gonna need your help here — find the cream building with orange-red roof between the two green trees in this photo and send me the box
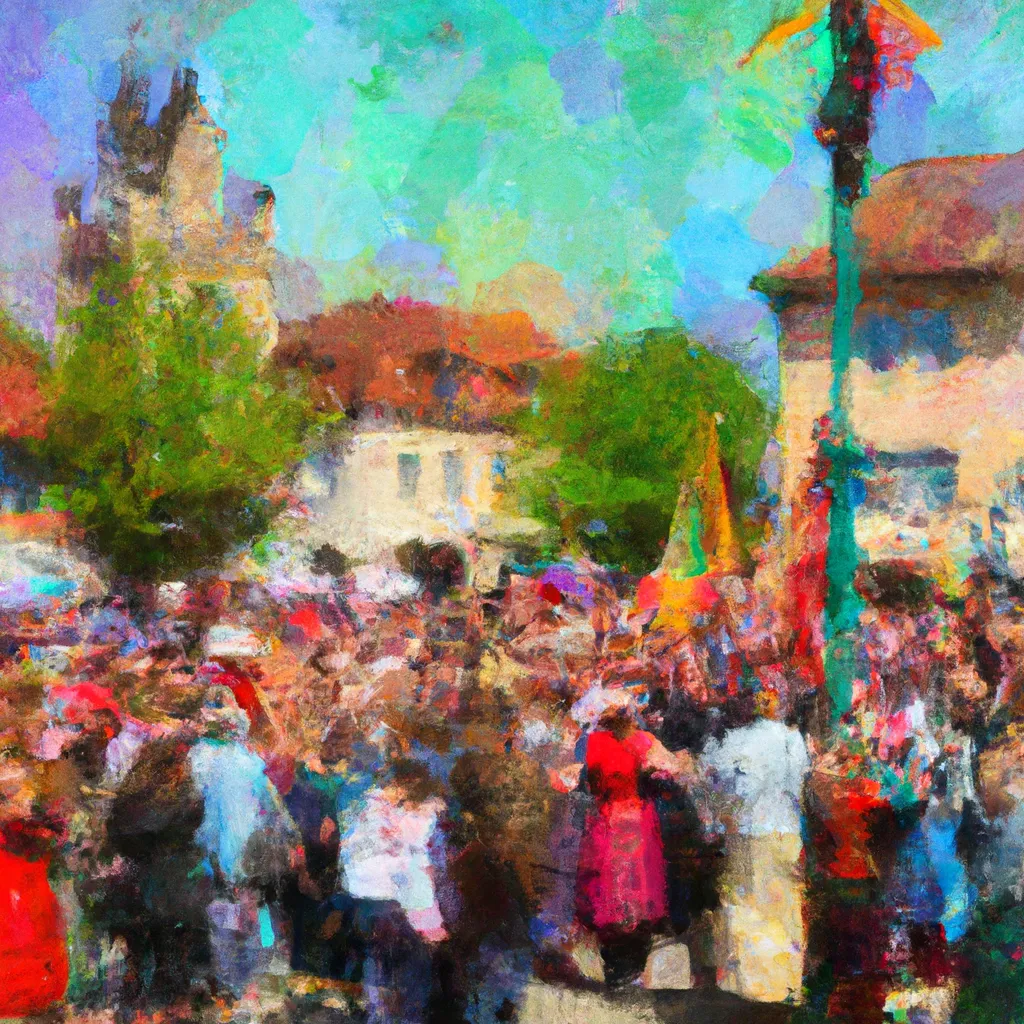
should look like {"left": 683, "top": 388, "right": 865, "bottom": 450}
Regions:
{"left": 274, "top": 295, "right": 557, "bottom": 558}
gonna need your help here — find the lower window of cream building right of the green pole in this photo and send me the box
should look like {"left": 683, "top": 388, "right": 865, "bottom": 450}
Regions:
{"left": 864, "top": 447, "right": 959, "bottom": 516}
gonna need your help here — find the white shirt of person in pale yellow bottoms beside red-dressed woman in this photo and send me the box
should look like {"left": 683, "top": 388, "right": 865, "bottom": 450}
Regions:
{"left": 701, "top": 720, "right": 810, "bottom": 836}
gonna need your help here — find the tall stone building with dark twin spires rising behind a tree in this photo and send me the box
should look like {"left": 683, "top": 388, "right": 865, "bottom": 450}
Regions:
{"left": 54, "top": 59, "right": 278, "bottom": 358}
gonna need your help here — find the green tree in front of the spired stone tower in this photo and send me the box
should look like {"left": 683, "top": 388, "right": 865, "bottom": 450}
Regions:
{"left": 40, "top": 251, "right": 313, "bottom": 580}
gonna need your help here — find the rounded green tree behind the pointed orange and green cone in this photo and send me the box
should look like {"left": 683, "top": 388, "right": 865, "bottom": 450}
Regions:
{"left": 517, "top": 329, "right": 772, "bottom": 572}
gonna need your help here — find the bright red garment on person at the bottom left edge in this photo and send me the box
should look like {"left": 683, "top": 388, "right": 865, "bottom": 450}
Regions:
{"left": 0, "top": 821, "right": 68, "bottom": 1018}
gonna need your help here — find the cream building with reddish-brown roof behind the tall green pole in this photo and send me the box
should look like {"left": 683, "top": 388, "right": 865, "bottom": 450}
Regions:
{"left": 754, "top": 153, "right": 1024, "bottom": 568}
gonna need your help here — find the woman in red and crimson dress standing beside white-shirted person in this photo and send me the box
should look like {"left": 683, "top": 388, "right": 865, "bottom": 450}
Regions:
{"left": 577, "top": 690, "right": 693, "bottom": 985}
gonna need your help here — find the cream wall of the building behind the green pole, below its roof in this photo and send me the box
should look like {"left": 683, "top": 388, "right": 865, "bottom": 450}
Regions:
{"left": 773, "top": 275, "right": 1024, "bottom": 570}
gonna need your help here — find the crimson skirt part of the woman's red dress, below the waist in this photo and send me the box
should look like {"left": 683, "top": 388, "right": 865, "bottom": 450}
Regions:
{"left": 577, "top": 800, "right": 669, "bottom": 932}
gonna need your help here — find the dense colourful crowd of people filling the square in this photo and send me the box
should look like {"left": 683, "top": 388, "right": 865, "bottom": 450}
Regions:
{"left": 0, "top": 536, "right": 1024, "bottom": 1022}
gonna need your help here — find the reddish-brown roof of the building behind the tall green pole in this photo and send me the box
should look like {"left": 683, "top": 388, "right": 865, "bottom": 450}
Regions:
{"left": 753, "top": 152, "right": 1024, "bottom": 297}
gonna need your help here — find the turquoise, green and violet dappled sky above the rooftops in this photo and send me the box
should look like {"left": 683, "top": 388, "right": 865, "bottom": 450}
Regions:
{"left": 0, "top": 0, "right": 1024, "bottom": 394}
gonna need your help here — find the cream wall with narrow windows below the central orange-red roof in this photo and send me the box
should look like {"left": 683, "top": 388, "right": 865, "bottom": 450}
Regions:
{"left": 299, "top": 429, "right": 538, "bottom": 558}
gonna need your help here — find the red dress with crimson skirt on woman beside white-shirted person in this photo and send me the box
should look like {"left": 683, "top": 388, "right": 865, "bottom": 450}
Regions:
{"left": 577, "top": 730, "right": 669, "bottom": 932}
